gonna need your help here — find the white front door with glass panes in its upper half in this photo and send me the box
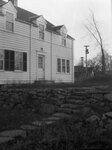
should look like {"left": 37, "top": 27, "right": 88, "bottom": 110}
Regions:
{"left": 37, "top": 55, "right": 45, "bottom": 80}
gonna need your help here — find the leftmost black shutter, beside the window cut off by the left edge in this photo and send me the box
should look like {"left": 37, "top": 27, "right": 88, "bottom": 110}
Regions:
{"left": 4, "top": 50, "right": 10, "bottom": 71}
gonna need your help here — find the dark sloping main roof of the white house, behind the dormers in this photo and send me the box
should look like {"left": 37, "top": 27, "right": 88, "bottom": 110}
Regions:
{"left": 0, "top": 0, "right": 73, "bottom": 39}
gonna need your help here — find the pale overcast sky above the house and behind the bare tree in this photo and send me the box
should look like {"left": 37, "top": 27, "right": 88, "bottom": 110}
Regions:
{"left": 18, "top": 0, "right": 112, "bottom": 62}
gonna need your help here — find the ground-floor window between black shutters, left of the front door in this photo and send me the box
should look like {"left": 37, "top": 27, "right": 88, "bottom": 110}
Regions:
{"left": 15, "top": 52, "right": 23, "bottom": 70}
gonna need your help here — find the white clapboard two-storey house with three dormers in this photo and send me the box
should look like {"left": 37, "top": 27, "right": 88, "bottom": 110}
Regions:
{"left": 0, "top": 0, "right": 74, "bottom": 84}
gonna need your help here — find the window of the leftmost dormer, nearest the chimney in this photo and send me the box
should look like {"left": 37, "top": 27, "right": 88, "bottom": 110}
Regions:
{"left": 6, "top": 12, "right": 14, "bottom": 32}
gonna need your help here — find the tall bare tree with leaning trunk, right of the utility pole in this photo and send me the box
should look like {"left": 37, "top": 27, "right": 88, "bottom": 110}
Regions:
{"left": 84, "top": 11, "right": 105, "bottom": 73}
